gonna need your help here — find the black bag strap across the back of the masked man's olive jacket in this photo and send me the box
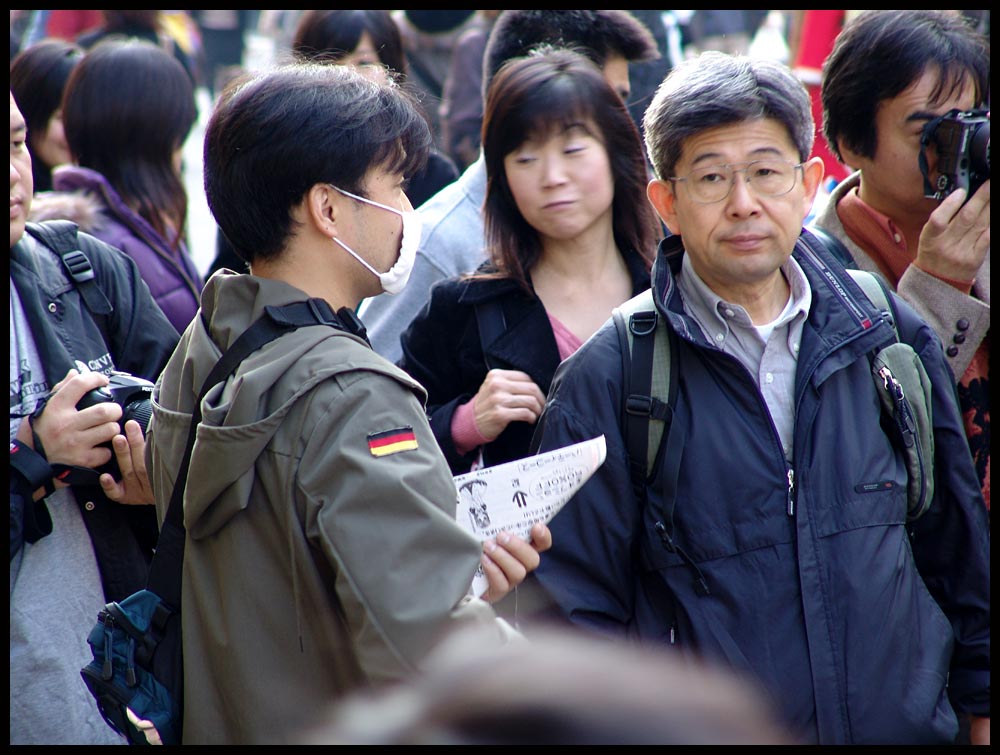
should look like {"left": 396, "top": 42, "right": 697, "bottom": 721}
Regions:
{"left": 147, "top": 299, "right": 354, "bottom": 607}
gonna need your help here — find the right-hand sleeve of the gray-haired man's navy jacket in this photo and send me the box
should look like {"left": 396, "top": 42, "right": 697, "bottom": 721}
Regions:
{"left": 895, "top": 290, "right": 990, "bottom": 716}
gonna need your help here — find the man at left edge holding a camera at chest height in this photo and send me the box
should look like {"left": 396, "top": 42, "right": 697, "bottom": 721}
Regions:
{"left": 9, "top": 95, "right": 178, "bottom": 744}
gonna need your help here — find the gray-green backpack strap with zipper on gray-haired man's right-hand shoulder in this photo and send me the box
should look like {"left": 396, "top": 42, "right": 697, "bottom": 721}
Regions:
{"left": 847, "top": 270, "right": 934, "bottom": 521}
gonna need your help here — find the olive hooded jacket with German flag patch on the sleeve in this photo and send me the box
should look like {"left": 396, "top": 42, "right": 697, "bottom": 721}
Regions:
{"left": 147, "top": 271, "right": 510, "bottom": 744}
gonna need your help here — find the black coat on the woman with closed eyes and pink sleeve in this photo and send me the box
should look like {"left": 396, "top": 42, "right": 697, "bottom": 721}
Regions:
{"left": 399, "top": 253, "right": 649, "bottom": 475}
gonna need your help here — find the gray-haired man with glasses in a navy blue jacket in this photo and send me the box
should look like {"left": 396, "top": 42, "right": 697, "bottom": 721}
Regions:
{"left": 522, "top": 52, "right": 990, "bottom": 744}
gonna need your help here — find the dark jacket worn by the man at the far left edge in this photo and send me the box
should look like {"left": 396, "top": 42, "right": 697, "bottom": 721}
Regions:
{"left": 10, "top": 224, "right": 178, "bottom": 600}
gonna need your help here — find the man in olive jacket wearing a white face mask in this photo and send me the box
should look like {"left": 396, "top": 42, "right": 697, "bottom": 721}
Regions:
{"left": 147, "top": 66, "right": 551, "bottom": 744}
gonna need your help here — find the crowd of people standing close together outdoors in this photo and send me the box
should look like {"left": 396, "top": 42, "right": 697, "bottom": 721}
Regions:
{"left": 10, "top": 10, "right": 990, "bottom": 745}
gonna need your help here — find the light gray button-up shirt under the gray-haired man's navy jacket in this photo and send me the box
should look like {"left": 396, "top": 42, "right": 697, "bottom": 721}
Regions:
{"left": 677, "top": 255, "right": 812, "bottom": 461}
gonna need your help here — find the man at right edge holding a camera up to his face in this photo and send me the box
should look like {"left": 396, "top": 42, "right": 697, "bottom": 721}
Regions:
{"left": 815, "top": 10, "right": 990, "bottom": 511}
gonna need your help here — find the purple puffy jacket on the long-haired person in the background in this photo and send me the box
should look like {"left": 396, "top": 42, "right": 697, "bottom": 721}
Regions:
{"left": 52, "top": 165, "right": 205, "bottom": 333}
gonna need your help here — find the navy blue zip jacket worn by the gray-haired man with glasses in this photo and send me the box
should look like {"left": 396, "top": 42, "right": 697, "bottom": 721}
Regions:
{"left": 533, "top": 232, "right": 990, "bottom": 744}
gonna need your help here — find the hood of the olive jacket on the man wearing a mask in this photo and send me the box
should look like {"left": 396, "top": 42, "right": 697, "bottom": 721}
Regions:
{"left": 153, "top": 271, "right": 415, "bottom": 538}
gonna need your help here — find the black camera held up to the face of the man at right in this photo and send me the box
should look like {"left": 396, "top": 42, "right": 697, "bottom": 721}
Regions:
{"left": 920, "top": 110, "right": 990, "bottom": 199}
